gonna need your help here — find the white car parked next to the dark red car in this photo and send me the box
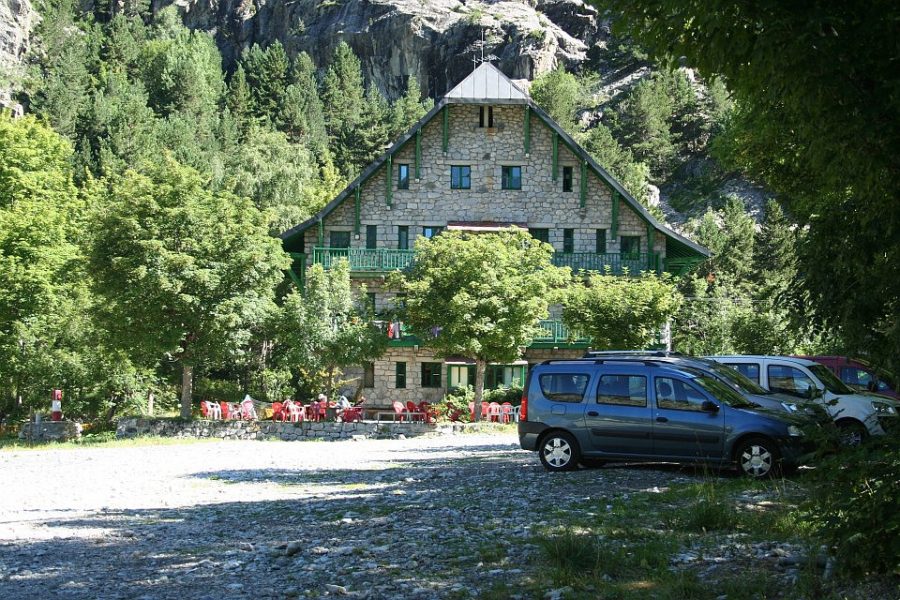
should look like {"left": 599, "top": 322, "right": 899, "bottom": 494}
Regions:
{"left": 707, "top": 356, "right": 900, "bottom": 444}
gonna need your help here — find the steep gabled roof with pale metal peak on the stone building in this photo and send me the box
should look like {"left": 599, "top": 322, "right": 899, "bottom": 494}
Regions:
{"left": 279, "top": 63, "right": 710, "bottom": 258}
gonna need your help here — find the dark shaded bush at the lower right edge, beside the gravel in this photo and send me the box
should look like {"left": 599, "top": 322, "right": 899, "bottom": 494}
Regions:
{"left": 804, "top": 436, "right": 900, "bottom": 575}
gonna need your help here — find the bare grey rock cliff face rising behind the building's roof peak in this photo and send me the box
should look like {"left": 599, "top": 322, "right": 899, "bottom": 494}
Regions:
{"left": 151, "top": 0, "right": 600, "bottom": 97}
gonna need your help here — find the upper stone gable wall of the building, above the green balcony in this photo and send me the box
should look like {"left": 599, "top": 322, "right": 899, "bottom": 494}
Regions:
{"left": 304, "top": 104, "right": 665, "bottom": 260}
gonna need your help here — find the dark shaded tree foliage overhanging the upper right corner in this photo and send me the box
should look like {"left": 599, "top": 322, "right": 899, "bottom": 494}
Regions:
{"left": 604, "top": 0, "right": 900, "bottom": 376}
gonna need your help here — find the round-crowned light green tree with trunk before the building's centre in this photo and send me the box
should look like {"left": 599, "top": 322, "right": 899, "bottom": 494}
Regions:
{"left": 399, "top": 228, "right": 567, "bottom": 415}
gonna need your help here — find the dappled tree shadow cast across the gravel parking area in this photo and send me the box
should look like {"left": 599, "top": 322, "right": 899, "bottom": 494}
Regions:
{"left": 0, "top": 444, "right": 716, "bottom": 600}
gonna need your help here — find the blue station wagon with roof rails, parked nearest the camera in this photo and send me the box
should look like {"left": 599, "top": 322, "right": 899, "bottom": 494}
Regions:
{"left": 519, "top": 358, "right": 808, "bottom": 478}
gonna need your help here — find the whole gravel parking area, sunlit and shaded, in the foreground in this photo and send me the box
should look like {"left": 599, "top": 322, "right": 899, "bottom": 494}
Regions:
{"left": 0, "top": 434, "right": 708, "bottom": 600}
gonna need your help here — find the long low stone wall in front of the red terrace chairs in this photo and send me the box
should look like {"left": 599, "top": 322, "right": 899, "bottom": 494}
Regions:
{"left": 116, "top": 418, "right": 453, "bottom": 441}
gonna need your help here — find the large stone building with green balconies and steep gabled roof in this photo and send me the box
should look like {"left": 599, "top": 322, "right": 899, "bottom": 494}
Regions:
{"left": 281, "top": 63, "right": 708, "bottom": 405}
